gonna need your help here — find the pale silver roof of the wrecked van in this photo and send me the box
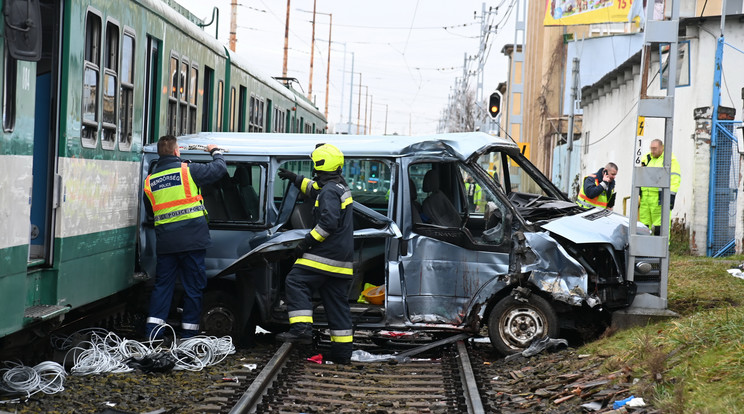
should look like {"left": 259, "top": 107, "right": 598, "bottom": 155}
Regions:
{"left": 144, "top": 132, "right": 517, "bottom": 160}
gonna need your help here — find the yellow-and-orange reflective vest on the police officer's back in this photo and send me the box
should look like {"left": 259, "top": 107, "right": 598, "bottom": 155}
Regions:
{"left": 145, "top": 163, "right": 207, "bottom": 226}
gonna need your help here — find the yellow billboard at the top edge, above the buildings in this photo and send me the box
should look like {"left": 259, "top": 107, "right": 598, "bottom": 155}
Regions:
{"left": 543, "top": 0, "right": 643, "bottom": 26}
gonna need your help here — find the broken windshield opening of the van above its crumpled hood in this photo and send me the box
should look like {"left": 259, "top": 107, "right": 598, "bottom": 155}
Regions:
{"left": 478, "top": 148, "right": 579, "bottom": 221}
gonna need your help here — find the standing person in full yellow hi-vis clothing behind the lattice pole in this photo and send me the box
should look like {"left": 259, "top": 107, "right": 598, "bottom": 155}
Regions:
{"left": 638, "top": 139, "right": 682, "bottom": 236}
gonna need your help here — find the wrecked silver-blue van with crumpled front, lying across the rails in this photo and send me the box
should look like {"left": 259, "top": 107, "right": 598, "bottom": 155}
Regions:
{"left": 140, "top": 133, "right": 636, "bottom": 354}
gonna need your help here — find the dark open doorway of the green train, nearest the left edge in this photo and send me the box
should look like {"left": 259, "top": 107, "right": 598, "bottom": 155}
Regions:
{"left": 27, "top": 0, "right": 62, "bottom": 266}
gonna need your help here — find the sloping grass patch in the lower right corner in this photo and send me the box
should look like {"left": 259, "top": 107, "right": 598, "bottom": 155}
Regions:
{"left": 580, "top": 256, "right": 744, "bottom": 413}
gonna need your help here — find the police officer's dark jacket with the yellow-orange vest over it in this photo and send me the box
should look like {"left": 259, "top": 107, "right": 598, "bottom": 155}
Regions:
{"left": 144, "top": 151, "right": 227, "bottom": 254}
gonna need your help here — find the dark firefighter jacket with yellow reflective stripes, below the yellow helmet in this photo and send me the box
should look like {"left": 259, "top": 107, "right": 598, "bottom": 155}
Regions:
{"left": 295, "top": 173, "right": 354, "bottom": 278}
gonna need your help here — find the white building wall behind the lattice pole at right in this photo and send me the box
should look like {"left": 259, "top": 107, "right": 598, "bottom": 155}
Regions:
{"left": 578, "top": 19, "right": 744, "bottom": 254}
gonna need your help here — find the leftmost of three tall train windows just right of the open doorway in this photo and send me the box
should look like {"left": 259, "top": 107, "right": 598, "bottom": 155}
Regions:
{"left": 80, "top": 11, "right": 101, "bottom": 148}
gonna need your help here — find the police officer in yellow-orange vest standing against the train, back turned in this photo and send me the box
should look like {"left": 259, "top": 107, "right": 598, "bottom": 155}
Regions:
{"left": 145, "top": 135, "right": 227, "bottom": 338}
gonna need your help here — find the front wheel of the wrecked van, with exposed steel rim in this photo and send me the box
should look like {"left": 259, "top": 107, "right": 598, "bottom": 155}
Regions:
{"left": 488, "top": 295, "right": 560, "bottom": 355}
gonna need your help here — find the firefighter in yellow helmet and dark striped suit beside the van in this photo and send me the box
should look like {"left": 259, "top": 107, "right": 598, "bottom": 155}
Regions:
{"left": 277, "top": 144, "right": 354, "bottom": 364}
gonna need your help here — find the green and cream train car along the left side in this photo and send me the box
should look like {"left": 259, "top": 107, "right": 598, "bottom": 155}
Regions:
{"left": 0, "top": 0, "right": 326, "bottom": 350}
